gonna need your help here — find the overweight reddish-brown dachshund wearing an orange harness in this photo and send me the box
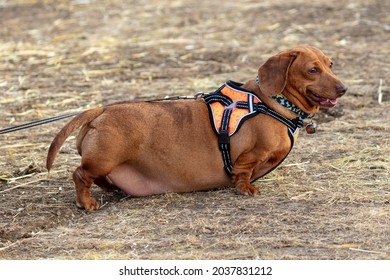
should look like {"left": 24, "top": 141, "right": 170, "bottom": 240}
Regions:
{"left": 46, "top": 46, "right": 347, "bottom": 211}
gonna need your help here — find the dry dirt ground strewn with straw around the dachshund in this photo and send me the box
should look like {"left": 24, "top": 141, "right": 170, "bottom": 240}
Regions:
{"left": 0, "top": 0, "right": 390, "bottom": 259}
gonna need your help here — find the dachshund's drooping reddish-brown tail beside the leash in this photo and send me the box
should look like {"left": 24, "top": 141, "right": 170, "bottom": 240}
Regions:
{"left": 46, "top": 107, "right": 104, "bottom": 171}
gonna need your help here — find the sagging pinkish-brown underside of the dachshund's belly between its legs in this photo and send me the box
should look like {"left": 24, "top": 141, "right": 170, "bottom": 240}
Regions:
{"left": 107, "top": 164, "right": 231, "bottom": 196}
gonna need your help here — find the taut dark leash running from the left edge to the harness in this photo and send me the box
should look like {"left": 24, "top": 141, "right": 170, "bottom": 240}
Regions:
{"left": 0, "top": 92, "right": 205, "bottom": 135}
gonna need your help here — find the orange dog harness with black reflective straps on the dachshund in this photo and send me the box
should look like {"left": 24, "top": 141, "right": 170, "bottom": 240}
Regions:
{"left": 203, "top": 81, "right": 303, "bottom": 175}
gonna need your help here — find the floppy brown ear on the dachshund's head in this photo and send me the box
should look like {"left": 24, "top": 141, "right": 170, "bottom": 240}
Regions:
{"left": 259, "top": 52, "right": 298, "bottom": 96}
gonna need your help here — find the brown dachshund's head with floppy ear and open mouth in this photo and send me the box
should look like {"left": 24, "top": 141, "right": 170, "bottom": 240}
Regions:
{"left": 259, "top": 46, "right": 347, "bottom": 114}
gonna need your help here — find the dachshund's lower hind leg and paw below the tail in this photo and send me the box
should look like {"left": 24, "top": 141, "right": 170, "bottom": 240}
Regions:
{"left": 73, "top": 166, "right": 100, "bottom": 212}
